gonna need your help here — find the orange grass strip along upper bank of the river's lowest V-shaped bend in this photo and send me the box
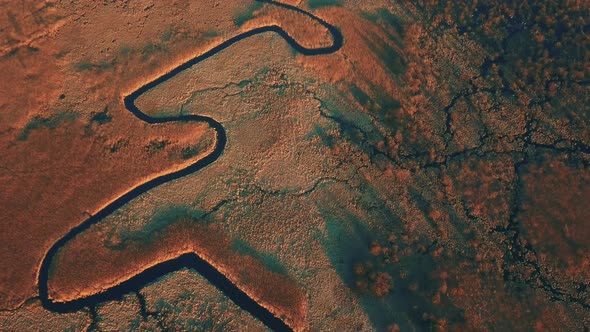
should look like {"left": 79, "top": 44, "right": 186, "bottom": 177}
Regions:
{"left": 49, "top": 220, "right": 306, "bottom": 331}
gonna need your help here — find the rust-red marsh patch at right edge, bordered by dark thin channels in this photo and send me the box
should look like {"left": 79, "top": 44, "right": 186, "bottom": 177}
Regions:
{"left": 518, "top": 155, "right": 590, "bottom": 281}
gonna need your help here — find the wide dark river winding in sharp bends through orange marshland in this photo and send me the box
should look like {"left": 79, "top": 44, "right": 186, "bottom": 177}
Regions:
{"left": 38, "top": 0, "right": 343, "bottom": 331}
